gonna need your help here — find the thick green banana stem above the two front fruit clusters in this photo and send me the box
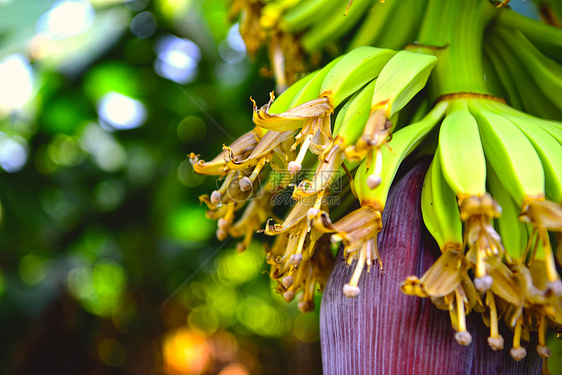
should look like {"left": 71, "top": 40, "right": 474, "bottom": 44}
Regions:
{"left": 410, "top": 0, "right": 498, "bottom": 100}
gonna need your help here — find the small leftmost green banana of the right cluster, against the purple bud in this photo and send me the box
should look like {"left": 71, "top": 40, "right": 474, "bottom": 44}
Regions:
{"left": 421, "top": 154, "right": 464, "bottom": 252}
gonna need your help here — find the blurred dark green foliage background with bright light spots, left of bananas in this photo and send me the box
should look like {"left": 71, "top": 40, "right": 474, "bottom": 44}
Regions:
{"left": 0, "top": 0, "right": 321, "bottom": 375}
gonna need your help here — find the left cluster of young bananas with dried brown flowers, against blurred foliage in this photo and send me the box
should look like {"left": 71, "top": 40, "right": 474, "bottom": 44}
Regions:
{"left": 190, "top": 46, "right": 438, "bottom": 311}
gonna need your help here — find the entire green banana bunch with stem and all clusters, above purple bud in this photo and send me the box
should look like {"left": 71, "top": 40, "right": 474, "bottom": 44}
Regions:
{"left": 194, "top": 0, "right": 562, "bottom": 368}
